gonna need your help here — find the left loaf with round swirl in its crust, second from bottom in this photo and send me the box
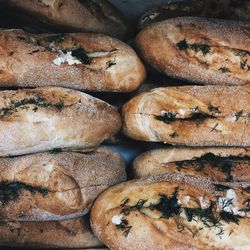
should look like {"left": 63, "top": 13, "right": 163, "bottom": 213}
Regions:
{"left": 0, "top": 148, "right": 126, "bottom": 221}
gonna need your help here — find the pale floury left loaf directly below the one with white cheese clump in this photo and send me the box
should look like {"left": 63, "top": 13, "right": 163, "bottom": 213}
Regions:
{"left": 0, "top": 87, "right": 121, "bottom": 156}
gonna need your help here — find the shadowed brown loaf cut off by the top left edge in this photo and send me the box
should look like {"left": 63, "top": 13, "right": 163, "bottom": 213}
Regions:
{"left": 1, "top": 0, "right": 128, "bottom": 38}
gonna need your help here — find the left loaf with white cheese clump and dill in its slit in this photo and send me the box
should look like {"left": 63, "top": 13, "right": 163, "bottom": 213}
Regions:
{"left": 0, "top": 29, "right": 146, "bottom": 92}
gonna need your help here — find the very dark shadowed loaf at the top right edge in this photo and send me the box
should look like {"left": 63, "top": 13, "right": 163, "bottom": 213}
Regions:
{"left": 138, "top": 0, "right": 250, "bottom": 29}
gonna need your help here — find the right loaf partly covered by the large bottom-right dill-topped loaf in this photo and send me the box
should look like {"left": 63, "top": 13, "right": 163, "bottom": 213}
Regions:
{"left": 133, "top": 147, "right": 250, "bottom": 182}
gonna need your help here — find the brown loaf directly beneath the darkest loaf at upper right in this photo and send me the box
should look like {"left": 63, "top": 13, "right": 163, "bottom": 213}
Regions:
{"left": 136, "top": 17, "right": 250, "bottom": 85}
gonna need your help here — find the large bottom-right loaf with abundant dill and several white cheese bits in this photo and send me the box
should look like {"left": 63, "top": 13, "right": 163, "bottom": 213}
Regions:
{"left": 91, "top": 174, "right": 250, "bottom": 250}
